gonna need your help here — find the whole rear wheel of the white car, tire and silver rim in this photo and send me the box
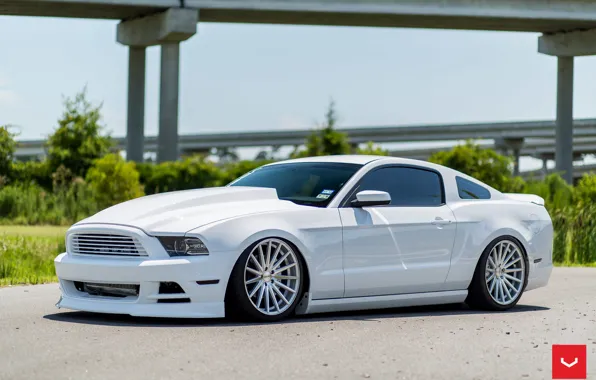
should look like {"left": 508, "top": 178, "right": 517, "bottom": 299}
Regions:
{"left": 466, "top": 236, "right": 528, "bottom": 310}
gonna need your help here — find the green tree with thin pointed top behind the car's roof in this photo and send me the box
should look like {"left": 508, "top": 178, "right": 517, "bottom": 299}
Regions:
{"left": 291, "top": 100, "right": 352, "bottom": 158}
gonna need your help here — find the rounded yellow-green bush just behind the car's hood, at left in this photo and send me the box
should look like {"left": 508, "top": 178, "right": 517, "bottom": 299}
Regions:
{"left": 87, "top": 153, "right": 144, "bottom": 208}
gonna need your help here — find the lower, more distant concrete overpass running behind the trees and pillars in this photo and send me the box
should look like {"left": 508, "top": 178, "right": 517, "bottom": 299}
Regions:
{"left": 16, "top": 119, "right": 596, "bottom": 174}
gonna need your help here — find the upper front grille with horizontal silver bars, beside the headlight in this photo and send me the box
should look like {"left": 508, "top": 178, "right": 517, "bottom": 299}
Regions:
{"left": 71, "top": 234, "right": 147, "bottom": 256}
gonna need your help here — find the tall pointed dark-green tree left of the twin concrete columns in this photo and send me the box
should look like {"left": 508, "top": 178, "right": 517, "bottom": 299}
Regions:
{"left": 48, "top": 88, "right": 112, "bottom": 177}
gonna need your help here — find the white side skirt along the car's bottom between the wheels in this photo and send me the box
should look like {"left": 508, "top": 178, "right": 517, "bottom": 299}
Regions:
{"left": 296, "top": 290, "right": 468, "bottom": 314}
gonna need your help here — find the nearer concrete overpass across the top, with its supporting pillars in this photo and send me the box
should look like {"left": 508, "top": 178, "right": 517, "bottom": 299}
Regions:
{"left": 0, "top": 0, "right": 596, "bottom": 182}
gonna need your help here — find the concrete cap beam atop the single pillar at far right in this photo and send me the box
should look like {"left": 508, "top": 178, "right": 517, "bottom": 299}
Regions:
{"left": 538, "top": 29, "right": 596, "bottom": 57}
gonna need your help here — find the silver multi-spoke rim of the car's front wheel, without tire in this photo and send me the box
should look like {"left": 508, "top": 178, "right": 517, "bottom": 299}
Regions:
{"left": 244, "top": 238, "right": 300, "bottom": 315}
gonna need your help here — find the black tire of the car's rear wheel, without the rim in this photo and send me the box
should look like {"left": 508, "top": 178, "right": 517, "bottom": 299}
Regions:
{"left": 465, "top": 236, "right": 529, "bottom": 311}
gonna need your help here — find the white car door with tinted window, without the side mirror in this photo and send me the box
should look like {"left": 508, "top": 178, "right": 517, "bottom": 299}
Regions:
{"left": 339, "top": 166, "right": 456, "bottom": 297}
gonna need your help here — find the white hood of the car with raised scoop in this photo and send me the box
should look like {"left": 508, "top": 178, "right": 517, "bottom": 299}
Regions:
{"left": 75, "top": 187, "right": 305, "bottom": 235}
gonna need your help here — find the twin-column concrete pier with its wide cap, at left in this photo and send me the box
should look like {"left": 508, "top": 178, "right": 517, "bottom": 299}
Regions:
{"left": 117, "top": 8, "right": 198, "bottom": 162}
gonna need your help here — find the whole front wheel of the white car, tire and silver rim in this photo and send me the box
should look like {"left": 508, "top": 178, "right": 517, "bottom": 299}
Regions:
{"left": 226, "top": 238, "right": 304, "bottom": 322}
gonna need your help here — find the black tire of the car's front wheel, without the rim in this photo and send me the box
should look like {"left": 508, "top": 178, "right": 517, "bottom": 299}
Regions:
{"left": 225, "top": 238, "right": 305, "bottom": 322}
